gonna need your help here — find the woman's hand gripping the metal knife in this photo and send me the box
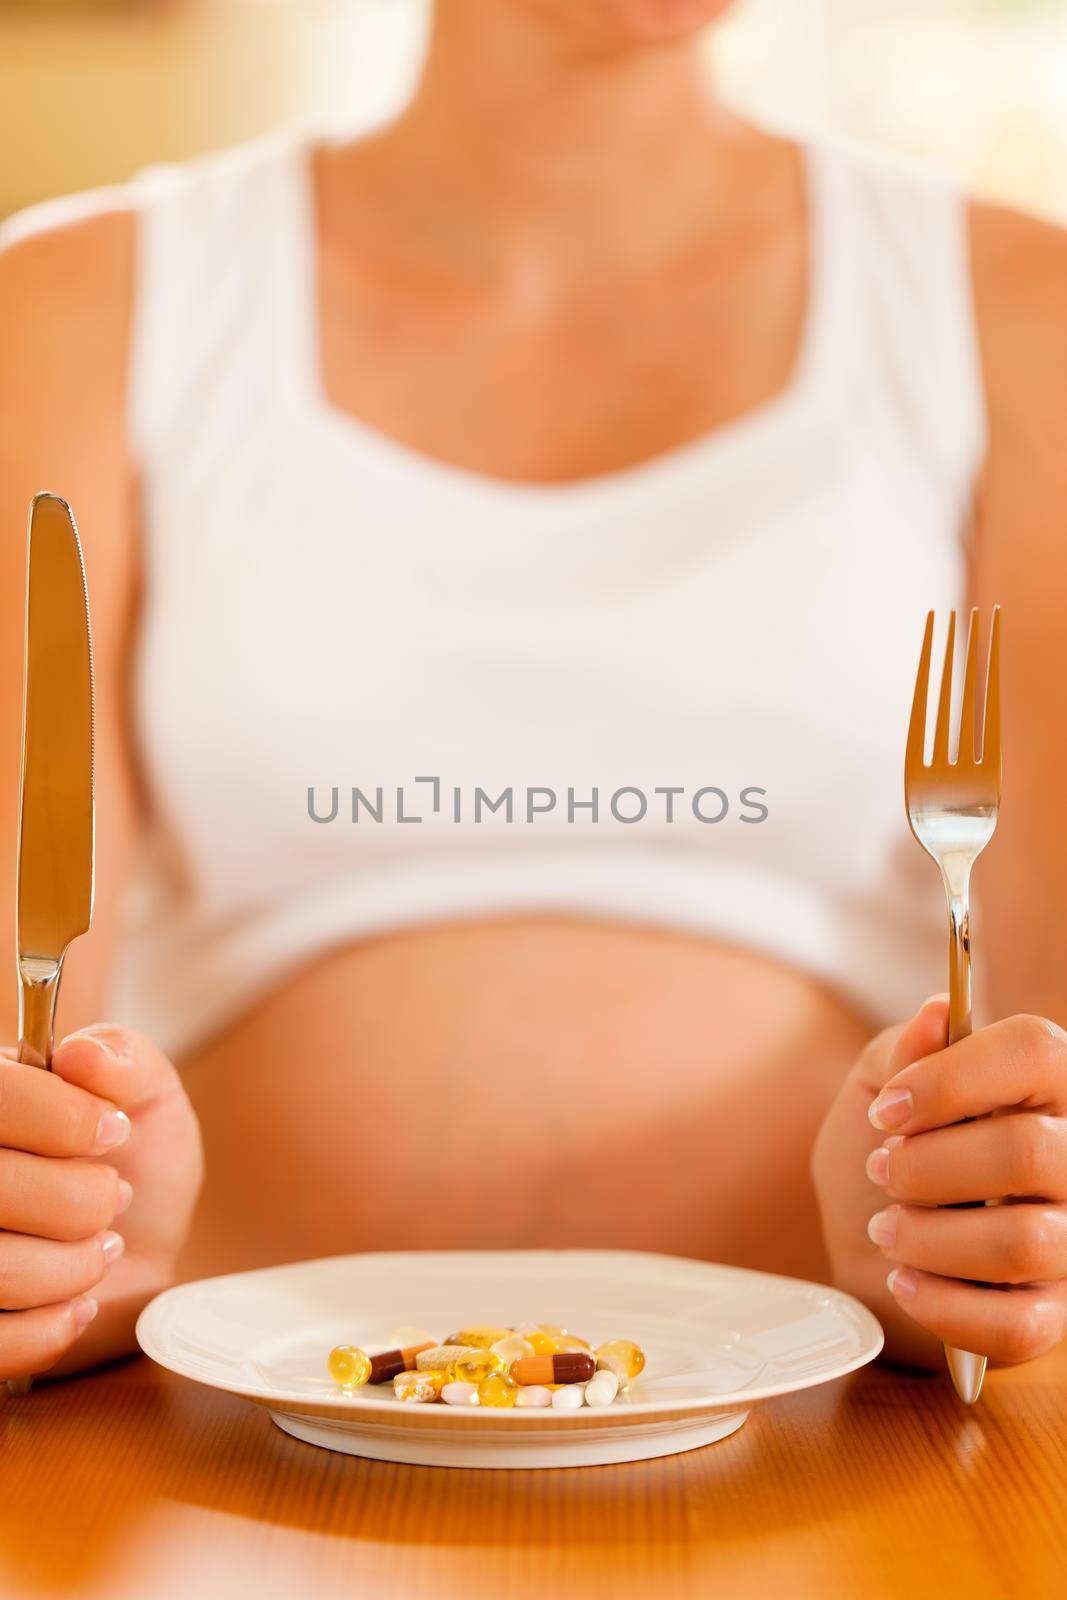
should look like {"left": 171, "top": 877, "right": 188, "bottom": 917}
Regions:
{"left": 0, "top": 1024, "right": 203, "bottom": 1378}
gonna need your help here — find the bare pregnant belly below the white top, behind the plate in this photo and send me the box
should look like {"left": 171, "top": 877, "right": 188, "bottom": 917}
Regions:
{"left": 177, "top": 918, "right": 870, "bottom": 1280}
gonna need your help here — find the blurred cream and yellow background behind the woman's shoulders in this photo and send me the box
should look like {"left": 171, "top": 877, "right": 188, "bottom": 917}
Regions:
{"left": 0, "top": 0, "right": 1067, "bottom": 219}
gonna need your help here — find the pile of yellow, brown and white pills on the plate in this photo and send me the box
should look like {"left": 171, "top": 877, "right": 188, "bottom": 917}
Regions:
{"left": 326, "top": 1323, "right": 645, "bottom": 1411}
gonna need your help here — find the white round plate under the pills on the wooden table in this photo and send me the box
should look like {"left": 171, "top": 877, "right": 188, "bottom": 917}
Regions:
{"left": 138, "top": 1250, "right": 881, "bottom": 1467}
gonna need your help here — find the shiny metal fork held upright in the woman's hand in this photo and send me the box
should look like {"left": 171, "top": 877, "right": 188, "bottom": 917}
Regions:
{"left": 904, "top": 606, "right": 1001, "bottom": 1405}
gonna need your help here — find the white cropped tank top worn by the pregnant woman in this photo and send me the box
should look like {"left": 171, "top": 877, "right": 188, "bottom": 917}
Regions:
{"left": 27, "top": 136, "right": 984, "bottom": 1054}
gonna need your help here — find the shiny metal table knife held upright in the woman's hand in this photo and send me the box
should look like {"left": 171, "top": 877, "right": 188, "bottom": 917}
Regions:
{"left": 8, "top": 494, "right": 94, "bottom": 1394}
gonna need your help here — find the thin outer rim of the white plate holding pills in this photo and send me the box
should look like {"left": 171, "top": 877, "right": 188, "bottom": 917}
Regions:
{"left": 134, "top": 1246, "right": 885, "bottom": 1430}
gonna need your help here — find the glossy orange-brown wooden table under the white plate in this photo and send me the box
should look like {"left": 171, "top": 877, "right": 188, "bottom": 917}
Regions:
{"left": 0, "top": 1352, "right": 1067, "bottom": 1600}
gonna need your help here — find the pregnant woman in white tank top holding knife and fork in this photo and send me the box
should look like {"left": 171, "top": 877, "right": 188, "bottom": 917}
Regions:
{"left": 0, "top": 0, "right": 1067, "bottom": 1376}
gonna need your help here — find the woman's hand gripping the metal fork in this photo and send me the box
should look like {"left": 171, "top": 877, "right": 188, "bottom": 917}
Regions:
{"left": 813, "top": 995, "right": 1067, "bottom": 1365}
